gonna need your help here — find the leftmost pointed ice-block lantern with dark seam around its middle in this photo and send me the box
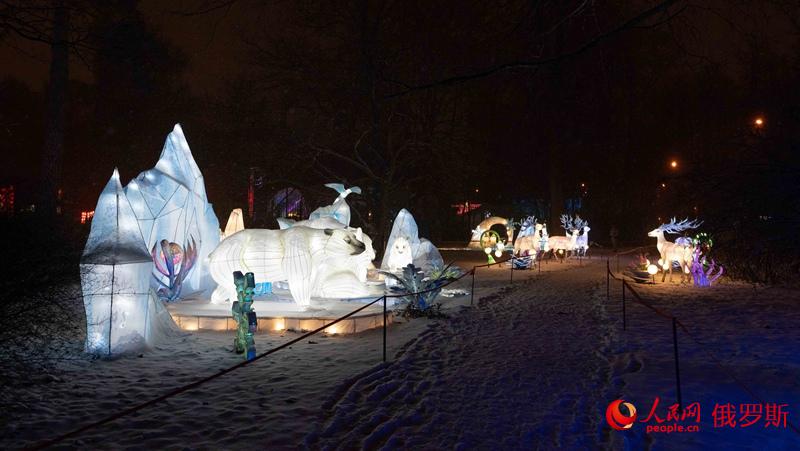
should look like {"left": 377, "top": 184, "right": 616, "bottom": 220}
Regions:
{"left": 80, "top": 169, "right": 163, "bottom": 355}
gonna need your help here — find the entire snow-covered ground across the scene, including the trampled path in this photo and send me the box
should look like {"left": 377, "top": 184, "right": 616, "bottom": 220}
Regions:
{"left": 0, "top": 252, "right": 800, "bottom": 449}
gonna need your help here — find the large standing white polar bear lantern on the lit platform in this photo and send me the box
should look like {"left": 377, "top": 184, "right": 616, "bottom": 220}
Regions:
{"left": 209, "top": 226, "right": 374, "bottom": 309}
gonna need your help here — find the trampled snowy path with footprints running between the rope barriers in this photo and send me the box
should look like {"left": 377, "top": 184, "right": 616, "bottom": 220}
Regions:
{"left": 306, "top": 262, "right": 611, "bottom": 449}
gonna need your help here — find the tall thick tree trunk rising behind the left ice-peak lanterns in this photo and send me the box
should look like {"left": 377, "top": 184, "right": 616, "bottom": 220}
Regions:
{"left": 37, "top": 0, "right": 69, "bottom": 216}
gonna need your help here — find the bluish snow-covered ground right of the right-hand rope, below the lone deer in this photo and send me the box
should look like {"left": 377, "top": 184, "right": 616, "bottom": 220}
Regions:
{"left": 607, "top": 264, "right": 800, "bottom": 450}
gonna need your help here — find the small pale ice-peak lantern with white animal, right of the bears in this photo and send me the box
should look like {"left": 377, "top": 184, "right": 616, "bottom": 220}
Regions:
{"left": 381, "top": 208, "right": 444, "bottom": 273}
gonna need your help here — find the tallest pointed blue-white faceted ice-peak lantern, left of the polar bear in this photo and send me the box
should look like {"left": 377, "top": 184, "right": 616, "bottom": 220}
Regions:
{"left": 125, "top": 124, "right": 220, "bottom": 293}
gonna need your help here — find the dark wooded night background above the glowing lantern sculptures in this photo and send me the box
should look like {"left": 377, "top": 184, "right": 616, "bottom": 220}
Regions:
{"left": 0, "top": 0, "right": 800, "bottom": 281}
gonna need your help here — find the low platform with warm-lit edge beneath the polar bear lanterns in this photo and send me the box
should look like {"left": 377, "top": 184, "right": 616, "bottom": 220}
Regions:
{"left": 167, "top": 295, "right": 394, "bottom": 334}
